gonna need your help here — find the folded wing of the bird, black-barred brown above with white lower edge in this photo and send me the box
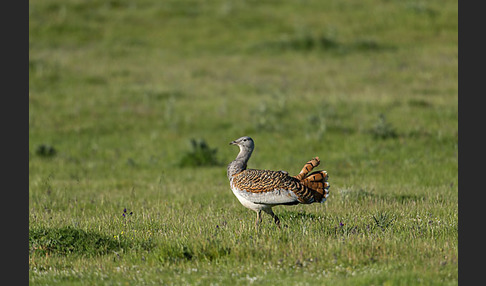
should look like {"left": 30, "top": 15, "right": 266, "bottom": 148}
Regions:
{"left": 231, "top": 169, "right": 314, "bottom": 205}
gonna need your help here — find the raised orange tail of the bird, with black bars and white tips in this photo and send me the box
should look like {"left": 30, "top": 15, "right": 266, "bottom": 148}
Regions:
{"left": 294, "top": 157, "right": 330, "bottom": 203}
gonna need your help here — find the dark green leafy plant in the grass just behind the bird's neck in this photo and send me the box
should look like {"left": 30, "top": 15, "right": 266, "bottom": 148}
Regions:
{"left": 179, "top": 139, "right": 221, "bottom": 167}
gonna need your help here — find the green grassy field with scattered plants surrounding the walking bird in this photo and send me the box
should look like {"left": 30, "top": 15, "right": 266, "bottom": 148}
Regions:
{"left": 29, "top": 0, "right": 458, "bottom": 285}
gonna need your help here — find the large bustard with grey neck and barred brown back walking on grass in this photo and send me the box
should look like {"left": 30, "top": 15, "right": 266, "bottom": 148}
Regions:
{"left": 227, "top": 136, "right": 330, "bottom": 228}
